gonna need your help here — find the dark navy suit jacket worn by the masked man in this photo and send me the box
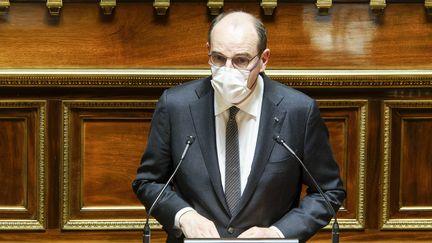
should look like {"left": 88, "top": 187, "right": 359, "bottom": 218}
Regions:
{"left": 133, "top": 74, "right": 345, "bottom": 242}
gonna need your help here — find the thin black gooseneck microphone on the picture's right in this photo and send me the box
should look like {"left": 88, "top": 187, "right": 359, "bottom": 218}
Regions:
{"left": 273, "top": 135, "right": 339, "bottom": 243}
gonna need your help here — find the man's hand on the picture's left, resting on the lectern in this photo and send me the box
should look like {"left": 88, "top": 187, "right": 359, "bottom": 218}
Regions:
{"left": 179, "top": 211, "right": 220, "bottom": 238}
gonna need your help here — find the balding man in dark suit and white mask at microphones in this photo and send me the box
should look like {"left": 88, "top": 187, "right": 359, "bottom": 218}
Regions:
{"left": 133, "top": 12, "right": 345, "bottom": 242}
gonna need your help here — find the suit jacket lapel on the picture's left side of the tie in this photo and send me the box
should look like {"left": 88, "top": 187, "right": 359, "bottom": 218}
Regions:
{"left": 189, "top": 80, "right": 229, "bottom": 214}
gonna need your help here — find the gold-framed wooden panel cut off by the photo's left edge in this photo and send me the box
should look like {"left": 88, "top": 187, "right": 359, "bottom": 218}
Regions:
{"left": 0, "top": 100, "right": 46, "bottom": 230}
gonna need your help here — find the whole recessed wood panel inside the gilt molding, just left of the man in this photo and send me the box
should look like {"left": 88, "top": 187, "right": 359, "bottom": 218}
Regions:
{"left": 63, "top": 104, "right": 153, "bottom": 220}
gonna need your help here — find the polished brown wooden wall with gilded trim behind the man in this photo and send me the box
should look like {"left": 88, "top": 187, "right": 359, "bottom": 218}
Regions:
{"left": 0, "top": 1, "right": 432, "bottom": 242}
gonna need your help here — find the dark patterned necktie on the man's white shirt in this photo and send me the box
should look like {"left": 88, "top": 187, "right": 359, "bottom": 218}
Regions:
{"left": 225, "top": 106, "right": 241, "bottom": 215}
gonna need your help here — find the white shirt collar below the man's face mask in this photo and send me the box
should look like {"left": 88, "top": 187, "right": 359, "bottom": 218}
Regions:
{"left": 214, "top": 75, "right": 264, "bottom": 118}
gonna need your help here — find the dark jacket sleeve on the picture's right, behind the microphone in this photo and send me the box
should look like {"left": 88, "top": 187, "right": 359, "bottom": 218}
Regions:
{"left": 274, "top": 102, "right": 346, "bottom": 242}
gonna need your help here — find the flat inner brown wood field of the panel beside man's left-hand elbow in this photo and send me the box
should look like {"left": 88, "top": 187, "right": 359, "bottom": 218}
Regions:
{"left": 81, "top": 117, "right": 150, "bottom": 209}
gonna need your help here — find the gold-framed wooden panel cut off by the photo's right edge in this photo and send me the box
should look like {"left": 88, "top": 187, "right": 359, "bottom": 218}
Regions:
{"left": 382, "top": 100, "right": 432, "bottom": 229}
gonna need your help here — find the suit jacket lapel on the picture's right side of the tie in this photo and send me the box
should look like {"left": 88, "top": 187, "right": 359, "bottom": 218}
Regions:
{"left": 234, "top": 75, "right": 286, "bottom": 216}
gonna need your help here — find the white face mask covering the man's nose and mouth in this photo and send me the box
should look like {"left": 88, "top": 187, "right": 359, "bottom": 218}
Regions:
{"left": 211, "top": 65, "right": 251, "bottom": 104}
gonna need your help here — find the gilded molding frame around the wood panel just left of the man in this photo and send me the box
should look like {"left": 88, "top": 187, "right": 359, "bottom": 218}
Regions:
{"left": 61, "top": 100, "right": 162, "bottom": 230}
